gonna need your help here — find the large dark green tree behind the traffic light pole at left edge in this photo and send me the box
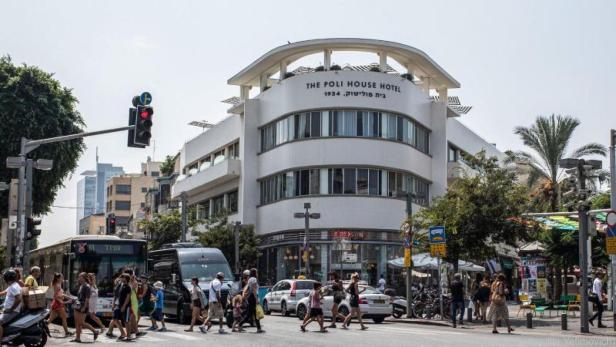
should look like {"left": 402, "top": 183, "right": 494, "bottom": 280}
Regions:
{"left": 0, "top": 57, "right": 84, "bottom": 216}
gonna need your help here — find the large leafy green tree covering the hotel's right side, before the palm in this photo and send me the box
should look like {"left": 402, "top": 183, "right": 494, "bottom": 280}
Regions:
{"left": 414, "top": 152, "right": 528, "bottom": 271}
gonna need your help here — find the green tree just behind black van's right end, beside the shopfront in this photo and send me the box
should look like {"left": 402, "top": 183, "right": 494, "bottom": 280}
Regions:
{"left": 199, "top": 213, "right": 261, "bottom": 269}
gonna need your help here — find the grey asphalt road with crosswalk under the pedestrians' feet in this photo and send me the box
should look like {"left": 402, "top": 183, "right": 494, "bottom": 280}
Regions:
{"left": 47, "top": 315, "right": 616, "bottom": 347}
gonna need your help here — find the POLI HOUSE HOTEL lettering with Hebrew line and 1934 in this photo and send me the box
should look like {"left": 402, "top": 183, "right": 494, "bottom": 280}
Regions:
{"left": 306, "top": 80, "right": 401, "bottom": 99}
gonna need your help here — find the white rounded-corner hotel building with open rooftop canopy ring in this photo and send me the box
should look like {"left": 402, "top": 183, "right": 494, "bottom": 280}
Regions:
{"left": 172, "top": 39, "right": 503, "bottom": 284}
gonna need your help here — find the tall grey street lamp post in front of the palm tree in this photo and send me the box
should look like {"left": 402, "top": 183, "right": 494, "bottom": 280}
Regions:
{"left": 558, "top": 158, "right": 602, "bottom": 333}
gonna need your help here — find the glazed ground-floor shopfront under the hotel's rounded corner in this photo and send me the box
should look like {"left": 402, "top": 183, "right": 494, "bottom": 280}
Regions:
{"left": 259, "top": 229, "right": 404, "bottom": 286}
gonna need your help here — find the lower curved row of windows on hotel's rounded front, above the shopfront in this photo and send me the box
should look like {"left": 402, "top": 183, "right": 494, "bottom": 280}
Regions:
{"left": 260, "top": 167, "right": 430, "bottom": 205}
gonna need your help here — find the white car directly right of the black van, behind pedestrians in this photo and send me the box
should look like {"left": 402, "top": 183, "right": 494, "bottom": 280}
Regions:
{"left": 263, "top": 280, "right": 316, "bottom": 316}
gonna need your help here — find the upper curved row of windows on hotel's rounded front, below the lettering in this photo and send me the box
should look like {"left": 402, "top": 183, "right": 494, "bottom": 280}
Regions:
{"left": 261, "top": 110, "right": 430, "bottom": 153}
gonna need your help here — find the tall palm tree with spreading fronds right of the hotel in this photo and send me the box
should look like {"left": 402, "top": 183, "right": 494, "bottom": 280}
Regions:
{"left": 507, "top": 114, "right": 607, "bottom": 212}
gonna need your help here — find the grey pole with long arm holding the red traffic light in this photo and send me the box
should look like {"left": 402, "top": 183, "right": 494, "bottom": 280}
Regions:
{"left": 15, "top": 125, "right": 135, "bottom": 267}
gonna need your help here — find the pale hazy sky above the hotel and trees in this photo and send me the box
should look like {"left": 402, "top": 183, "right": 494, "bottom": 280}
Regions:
{"left": 0, "top": 0, "right": 616, "bottom": 244}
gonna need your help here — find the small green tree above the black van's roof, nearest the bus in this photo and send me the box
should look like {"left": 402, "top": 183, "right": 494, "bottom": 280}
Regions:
{"left": 139, "top": 210, "right": 182, "bottom": 250}
